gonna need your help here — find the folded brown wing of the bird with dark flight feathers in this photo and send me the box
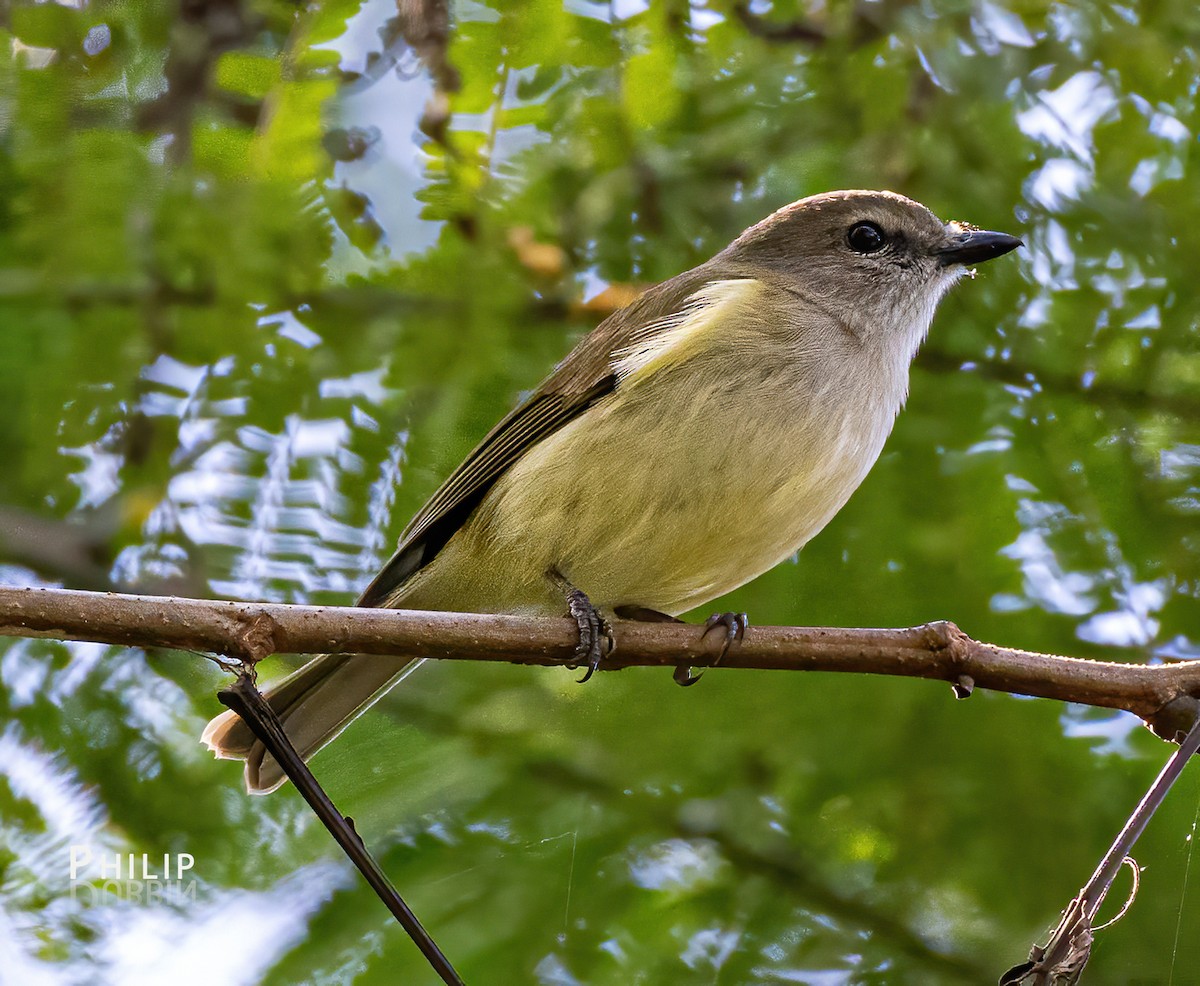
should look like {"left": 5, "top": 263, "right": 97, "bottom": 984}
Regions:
{"left": 359, "top": 264, "right": 713, "bottom": 606}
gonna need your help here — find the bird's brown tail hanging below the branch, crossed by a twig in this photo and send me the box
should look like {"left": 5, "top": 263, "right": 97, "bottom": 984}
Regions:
{"left": 200, "top": 654, "right": 421, "bottom": 794}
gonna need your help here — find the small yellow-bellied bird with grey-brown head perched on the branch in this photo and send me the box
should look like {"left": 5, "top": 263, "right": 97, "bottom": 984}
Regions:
{"left": 203, "top": 191, "right": 1021, "bottom": 793}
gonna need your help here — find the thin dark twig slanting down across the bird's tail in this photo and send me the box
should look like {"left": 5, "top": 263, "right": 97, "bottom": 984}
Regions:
{"left": 217, "top": 673, "right": 463, "bottom": 986}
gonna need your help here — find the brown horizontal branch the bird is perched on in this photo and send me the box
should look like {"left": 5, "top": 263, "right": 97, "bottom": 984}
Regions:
{"left": 7, "top": 588, "right": 1200, "bottom": 739}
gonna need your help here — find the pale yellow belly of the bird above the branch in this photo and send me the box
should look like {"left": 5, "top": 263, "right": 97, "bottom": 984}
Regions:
{"left": 396, "top": 347, "right": 902, "bottom": 614}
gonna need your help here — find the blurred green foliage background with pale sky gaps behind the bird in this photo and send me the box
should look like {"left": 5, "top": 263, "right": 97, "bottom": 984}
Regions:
{"left": 0, "top": 0, "right": 1200, "bottom": 986}
